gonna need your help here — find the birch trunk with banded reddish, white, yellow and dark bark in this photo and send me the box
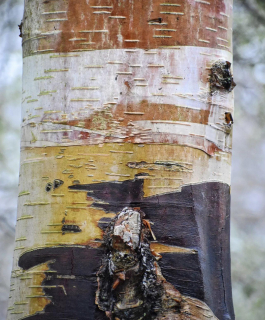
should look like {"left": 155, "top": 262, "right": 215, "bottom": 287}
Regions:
{"left": 8, "top": 0, "right": 234, "bottom": 320}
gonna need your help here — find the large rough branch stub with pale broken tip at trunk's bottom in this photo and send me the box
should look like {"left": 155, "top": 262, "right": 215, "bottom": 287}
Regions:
{"left": 95, "top": 207, "right": 217, "bottom": 320}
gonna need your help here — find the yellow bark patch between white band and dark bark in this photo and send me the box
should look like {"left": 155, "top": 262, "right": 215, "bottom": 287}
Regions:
{"left": 14, "top": 143, "right": 230, "bottom": 253}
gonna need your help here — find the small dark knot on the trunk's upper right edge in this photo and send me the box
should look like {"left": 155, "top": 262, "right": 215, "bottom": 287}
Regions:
{"left": 210, "top": 60, "right": 236, "bottom": 94}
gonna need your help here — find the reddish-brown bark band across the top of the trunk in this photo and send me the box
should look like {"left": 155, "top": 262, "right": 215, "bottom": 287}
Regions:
{"left": 23, "top": 0, "right": 232, "bottom": 57}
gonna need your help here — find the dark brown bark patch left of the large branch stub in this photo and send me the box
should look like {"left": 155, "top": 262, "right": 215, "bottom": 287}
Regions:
{"left": 19, "top": 246, "right": 107, "bottom": 320}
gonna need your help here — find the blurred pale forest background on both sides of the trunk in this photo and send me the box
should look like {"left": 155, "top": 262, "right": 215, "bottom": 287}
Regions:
{"left": 0, "top": 0, "right": 265, "bottom": 320}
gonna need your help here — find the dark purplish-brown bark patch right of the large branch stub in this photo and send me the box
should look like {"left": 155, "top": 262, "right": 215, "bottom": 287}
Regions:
{"left": 69, "top": 179, "right": 234, "bottom": 319}
